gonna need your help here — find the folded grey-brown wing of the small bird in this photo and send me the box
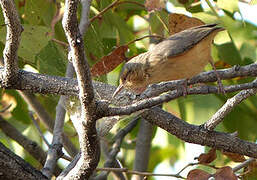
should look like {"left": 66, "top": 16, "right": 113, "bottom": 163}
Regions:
{"left": 151, "top": 24, "right": 224, "bottom": 58}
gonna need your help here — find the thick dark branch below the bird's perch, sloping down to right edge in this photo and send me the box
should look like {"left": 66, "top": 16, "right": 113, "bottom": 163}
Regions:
{"left": 142, "top": 108, "right": 257, "bottom": 158}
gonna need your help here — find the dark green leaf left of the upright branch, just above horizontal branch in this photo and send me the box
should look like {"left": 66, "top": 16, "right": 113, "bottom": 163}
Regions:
{"left": 35, "top": 41, "right": 68, "bottom": 76}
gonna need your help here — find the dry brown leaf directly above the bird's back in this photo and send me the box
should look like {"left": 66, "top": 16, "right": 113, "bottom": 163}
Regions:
{"left": 168, "top": 13, "right": 205, "bottom": 35}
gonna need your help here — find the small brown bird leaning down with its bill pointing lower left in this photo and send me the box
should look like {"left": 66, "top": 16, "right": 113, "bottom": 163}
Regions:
{"left": 113, "top": 24, "right": 224, "bottom": 97}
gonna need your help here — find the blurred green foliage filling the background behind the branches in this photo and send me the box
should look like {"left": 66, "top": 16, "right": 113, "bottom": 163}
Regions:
{"left": 0, "top": 0, "right": 257, "bottom": 179}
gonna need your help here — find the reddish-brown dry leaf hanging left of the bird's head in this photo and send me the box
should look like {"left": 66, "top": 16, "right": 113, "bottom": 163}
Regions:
{"left": 91, "top": 45, "right": 128, "bottom": 76}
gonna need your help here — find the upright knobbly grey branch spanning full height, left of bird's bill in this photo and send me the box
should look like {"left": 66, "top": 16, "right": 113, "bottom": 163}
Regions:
{"left": 62, "top": 0, "right": 100, "bottom": 179}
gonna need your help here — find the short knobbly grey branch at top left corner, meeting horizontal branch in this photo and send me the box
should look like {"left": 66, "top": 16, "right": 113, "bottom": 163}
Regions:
{"left": 0, "top": 0, "right": 23, "bottom": 83}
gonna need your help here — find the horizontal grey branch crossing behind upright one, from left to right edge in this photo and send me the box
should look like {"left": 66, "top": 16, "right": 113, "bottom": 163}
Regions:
{"left": 0, "top": 63, "right": 257, "bottom": 98}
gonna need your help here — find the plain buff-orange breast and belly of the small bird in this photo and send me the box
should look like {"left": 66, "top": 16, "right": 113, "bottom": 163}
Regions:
{"left": 148, "top": 33, "right": 214, "bottom": 84}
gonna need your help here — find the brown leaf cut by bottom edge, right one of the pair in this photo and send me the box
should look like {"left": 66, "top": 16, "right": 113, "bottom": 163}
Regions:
{"left": 214, "top": 166, "right": 237, "bottom": 180}
